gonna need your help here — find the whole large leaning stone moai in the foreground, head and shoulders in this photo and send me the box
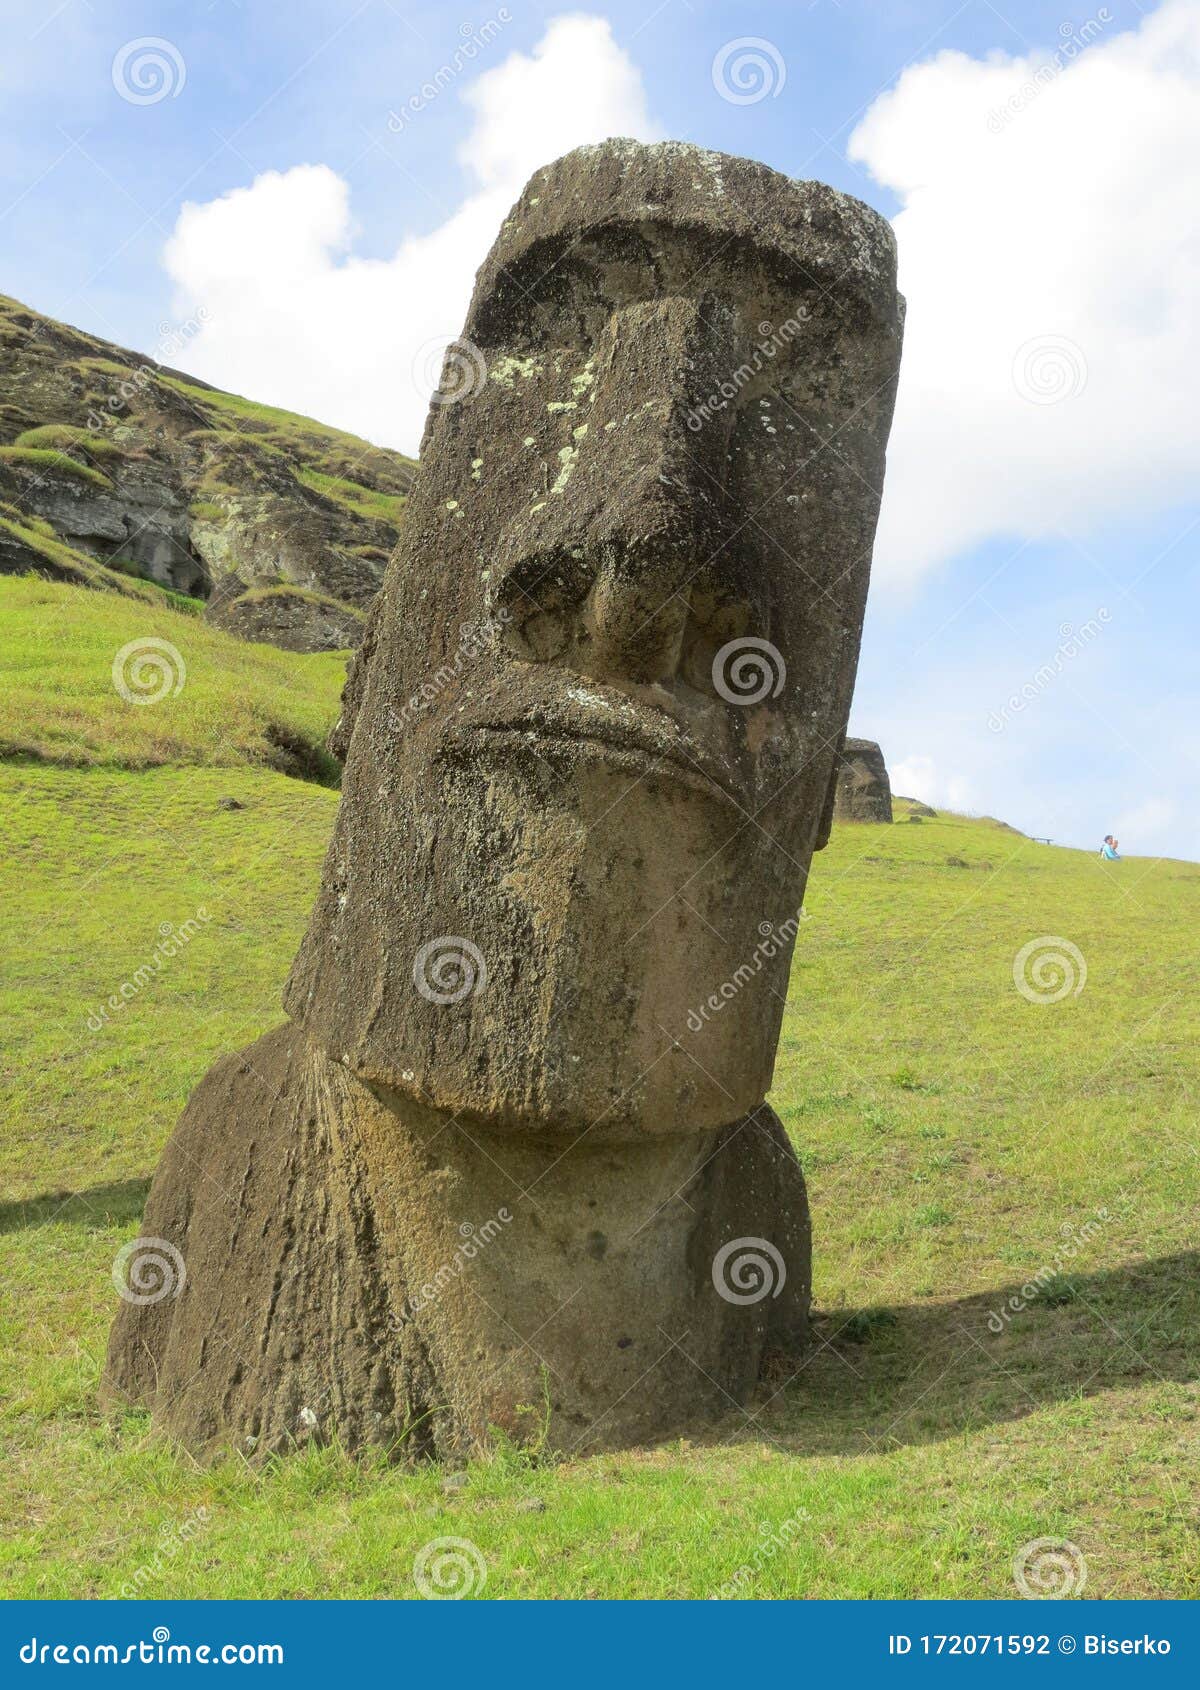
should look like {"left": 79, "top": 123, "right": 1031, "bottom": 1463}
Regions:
{"left": 106, "top": 140, "right": 903, "bottom": 1460}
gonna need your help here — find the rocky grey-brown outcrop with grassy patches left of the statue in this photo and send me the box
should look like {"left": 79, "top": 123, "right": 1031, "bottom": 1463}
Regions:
{"left": 0, "top": 296, "right": 414, "bottom": 649}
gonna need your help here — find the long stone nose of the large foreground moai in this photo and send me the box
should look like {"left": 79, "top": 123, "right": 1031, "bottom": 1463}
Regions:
{"left": 496, "top": 297, "right": 735, "bottom": 684}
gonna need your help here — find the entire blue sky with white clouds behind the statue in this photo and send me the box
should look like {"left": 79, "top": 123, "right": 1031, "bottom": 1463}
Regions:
{"left": 0, "top": 0, "right": 1200, "bottom": 859}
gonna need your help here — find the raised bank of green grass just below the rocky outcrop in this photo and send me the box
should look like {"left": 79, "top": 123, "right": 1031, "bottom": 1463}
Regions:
{"left": 0, "top": 576, "right": 345, "bottom": 781}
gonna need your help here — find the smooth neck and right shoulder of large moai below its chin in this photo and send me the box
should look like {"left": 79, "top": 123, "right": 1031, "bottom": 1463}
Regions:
{"left": 331, "top": 1058, "right": 808, "bottom": 1453}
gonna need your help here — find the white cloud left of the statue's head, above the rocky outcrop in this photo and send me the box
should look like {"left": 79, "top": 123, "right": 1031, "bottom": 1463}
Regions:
{"left": 164, "top": 15, "right": 659, "bottom": 451}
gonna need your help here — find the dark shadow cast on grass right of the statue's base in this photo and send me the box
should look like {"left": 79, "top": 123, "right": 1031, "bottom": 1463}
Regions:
{"left": 735, "top": 1251, "right": 1200, "bottom": 1455}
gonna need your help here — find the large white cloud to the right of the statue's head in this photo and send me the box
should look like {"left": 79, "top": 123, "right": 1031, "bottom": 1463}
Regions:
{"left": 848, "top": 0, "right": 1200, "bottom": 585}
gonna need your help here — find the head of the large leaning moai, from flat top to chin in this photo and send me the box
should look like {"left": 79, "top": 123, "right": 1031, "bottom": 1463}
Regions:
{"left": 286, "top": 140, "right": 903, "bottom": 1144}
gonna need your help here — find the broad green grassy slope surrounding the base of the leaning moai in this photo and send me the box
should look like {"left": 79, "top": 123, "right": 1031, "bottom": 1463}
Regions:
{"left": 0, "top": 590, "right": 1200, "bottom": 1595}
